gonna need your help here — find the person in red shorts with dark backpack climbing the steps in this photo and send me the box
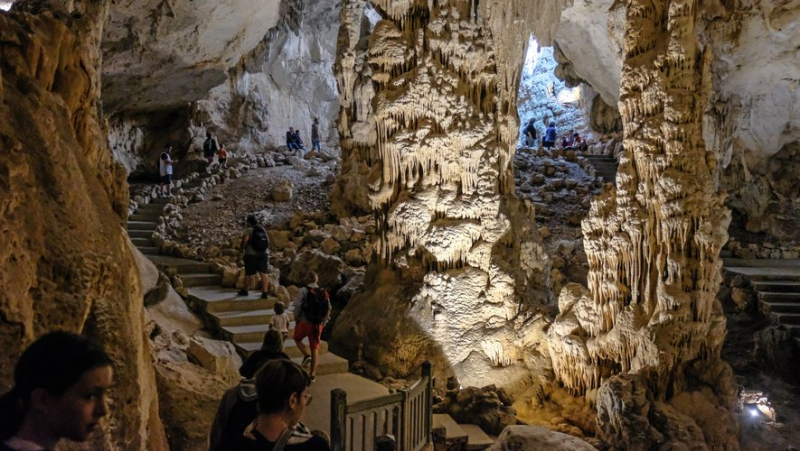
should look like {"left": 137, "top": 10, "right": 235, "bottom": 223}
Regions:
{"left": 292, "top": 271, "right": 331, "bottom": 382}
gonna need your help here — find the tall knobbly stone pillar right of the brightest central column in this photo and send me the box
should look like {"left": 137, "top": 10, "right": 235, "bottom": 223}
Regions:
{"left": 548, "top": 0, "right": 736, "bottom": 449}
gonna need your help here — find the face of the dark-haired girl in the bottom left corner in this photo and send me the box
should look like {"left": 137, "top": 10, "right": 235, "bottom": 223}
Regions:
{"left": 45, "top": 366, "right": 113, "bottom": 442}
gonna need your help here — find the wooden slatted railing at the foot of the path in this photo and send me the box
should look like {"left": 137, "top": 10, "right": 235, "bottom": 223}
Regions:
{"left": 331, "top": 362, "right": 433, "bottom": 451}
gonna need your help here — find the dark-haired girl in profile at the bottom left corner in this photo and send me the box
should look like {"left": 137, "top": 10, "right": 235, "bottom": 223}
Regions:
{"left": 0, "top": 332, "right": 113, "bottom": 451}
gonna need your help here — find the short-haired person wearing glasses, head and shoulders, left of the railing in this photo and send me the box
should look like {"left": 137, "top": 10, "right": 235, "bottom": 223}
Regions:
{"left": 216, "top": 359, "right": 331, "bottom": 451}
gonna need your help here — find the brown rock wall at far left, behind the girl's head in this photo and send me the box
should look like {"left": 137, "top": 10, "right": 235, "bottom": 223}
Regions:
{"left": 0, "top": 2, "right": 166, "bottom": 450}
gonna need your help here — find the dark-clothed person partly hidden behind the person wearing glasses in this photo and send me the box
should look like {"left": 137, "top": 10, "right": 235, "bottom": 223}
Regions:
{"left": 209, "top": 330, "right": 289, "bottom": 451}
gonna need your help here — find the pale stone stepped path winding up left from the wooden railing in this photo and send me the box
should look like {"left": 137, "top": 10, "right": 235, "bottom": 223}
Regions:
{"left": 123, "top": 189, "right": 389, "bottom": 432}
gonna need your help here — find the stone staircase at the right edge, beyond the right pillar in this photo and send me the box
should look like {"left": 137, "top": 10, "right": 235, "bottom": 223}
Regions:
{"left": 723, "top": 254, "right": 800, "bottom": 347}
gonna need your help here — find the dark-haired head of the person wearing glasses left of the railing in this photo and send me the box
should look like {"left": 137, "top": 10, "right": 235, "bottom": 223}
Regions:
{"left": 256, "top": 359, "right": 311, "bottom": 425}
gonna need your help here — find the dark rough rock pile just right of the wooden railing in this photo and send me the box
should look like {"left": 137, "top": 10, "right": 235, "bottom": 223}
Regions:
{"left": 433, "top": 382, "right": 521, "bottom": 435}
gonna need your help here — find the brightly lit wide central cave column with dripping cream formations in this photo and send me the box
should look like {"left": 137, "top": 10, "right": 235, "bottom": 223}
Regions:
{"left": 334, "top": 0, "right": 549, "bottom": 394}
